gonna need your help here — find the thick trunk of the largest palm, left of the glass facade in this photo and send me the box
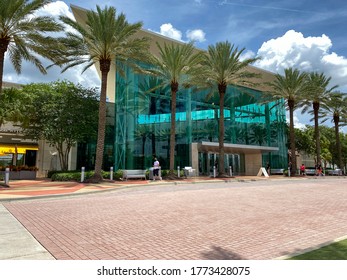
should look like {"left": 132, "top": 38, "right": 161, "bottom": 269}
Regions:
{"left": 89, "top": 60, "right": 111, "bottom": 182}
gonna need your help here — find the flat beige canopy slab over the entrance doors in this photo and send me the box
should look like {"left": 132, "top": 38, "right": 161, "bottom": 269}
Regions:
{"left": 197, "top": 142, "right": 279, "bottom": 154}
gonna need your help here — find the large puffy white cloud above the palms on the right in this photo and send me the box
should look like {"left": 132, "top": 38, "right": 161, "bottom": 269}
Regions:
{"left": 255, "top": 30, "right": 347, "bottom": 92}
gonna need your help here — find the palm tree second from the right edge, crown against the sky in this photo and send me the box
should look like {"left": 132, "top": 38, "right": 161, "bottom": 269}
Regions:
{"left": 302, "top": 72, "right": 337, "bottom": 164}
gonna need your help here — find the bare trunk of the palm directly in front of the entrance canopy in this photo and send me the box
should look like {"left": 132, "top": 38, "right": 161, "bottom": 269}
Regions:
{"left": 218, "top": 84, "right": 227, "bottom": 176}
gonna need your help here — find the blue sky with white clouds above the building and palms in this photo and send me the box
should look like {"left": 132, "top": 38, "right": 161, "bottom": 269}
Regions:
{"left": 5, "top": 0, "right": 347, "bottom": 128}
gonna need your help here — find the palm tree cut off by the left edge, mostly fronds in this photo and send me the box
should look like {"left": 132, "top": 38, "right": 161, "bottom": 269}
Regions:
{"left": 0, "top": 0, "right": 63, "bottom": 94}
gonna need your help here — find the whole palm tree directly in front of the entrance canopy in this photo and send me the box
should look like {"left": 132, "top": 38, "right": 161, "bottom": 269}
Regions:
{"left": 199, "top": 41, "right": 259, "bottom": 176}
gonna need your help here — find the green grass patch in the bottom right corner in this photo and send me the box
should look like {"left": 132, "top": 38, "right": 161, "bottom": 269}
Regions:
{"left": 289, "top": 239, "right": 347, "bottom": 260}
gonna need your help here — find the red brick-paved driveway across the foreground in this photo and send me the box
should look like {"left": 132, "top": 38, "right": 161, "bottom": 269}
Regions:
{"left": 4, "top": 178, "right": 347, "bottom": 260}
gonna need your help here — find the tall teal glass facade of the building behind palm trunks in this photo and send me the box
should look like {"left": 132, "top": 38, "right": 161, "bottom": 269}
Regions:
{"left": 78, "top": 61, "right": 287, "bottom": 171}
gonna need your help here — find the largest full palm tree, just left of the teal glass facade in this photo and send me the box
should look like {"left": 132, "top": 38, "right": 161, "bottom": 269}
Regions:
{"left": 55, "top": 6, "right": 149, "bottom": 182}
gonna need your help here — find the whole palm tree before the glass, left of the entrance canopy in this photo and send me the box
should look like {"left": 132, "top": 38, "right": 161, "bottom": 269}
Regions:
{"left": 150, "top": 43, "right": 202, "bottom": 175}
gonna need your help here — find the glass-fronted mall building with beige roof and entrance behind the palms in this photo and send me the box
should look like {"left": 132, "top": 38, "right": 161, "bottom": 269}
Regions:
{"left": 0, "top": 6, "right": 288, "bottom": 175}
